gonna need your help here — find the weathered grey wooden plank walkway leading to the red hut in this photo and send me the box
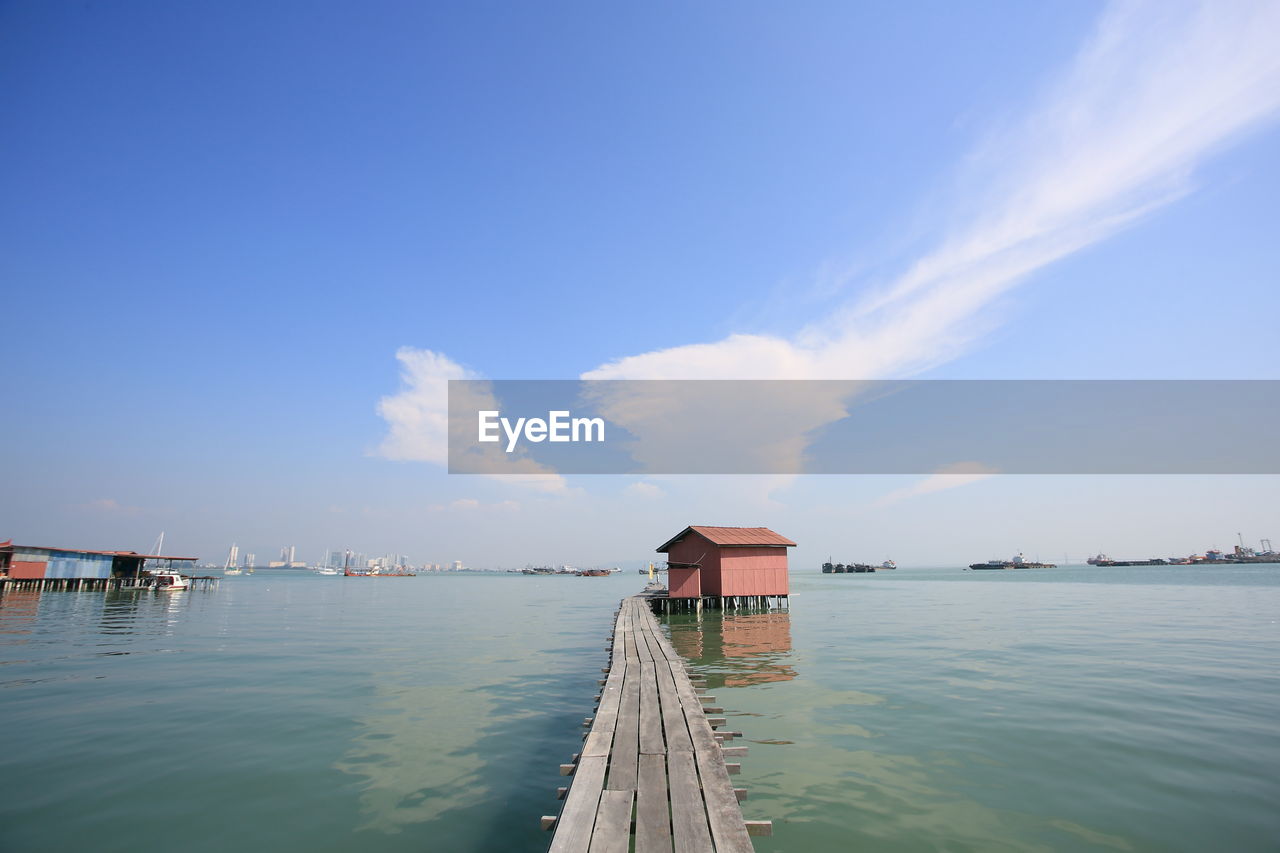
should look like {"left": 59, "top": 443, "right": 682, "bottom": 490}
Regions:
{"left": 543, "top": 596, "right": 772, "bottom": 853}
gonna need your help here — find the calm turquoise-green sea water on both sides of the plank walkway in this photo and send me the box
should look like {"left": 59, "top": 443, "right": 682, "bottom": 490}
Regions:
{"left": 0, "top": 566, "right": 1280, "bottom": 853}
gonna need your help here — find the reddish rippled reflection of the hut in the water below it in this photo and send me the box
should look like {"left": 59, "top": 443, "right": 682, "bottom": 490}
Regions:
{"left": 668, "top": 611, "right": 796, "bottom": 686}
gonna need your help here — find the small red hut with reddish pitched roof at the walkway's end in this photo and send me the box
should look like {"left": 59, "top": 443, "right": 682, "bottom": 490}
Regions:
{"left": 658, "top": 525, "right": 796, "bottom": 598}
